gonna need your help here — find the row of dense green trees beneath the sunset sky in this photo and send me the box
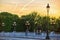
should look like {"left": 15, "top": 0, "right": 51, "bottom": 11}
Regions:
{"left": 0, "top": 12, "right": 60, "bottom": 32}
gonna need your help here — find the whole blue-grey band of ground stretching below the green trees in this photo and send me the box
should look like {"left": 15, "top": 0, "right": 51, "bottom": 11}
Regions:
{"left": 0, "top": 32, "right": 60, "bottom": 40}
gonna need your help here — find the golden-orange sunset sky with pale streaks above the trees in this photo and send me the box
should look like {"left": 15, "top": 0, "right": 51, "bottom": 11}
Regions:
{"left": 0, "top": 0, "right": 60, "bottom": 17}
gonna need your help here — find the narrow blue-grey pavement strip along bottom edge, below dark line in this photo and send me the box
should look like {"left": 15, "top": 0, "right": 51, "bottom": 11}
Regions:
{"left": 0, "top": 37, "right": 60, "bottom": 40}
